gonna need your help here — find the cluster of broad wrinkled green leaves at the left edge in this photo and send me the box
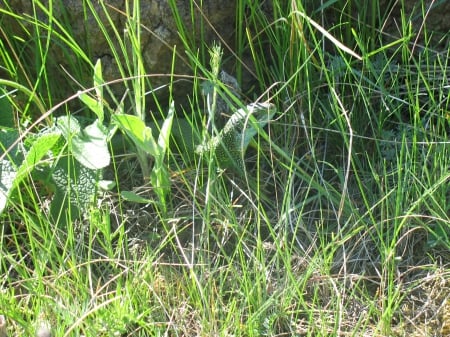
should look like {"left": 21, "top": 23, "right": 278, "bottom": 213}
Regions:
{"left": 0, "top": 61, "right": 110, "bottom": 222}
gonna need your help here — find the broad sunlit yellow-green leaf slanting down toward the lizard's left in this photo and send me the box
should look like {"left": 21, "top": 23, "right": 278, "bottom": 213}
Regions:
{"left": 113, "top": 115, "right": 160, "bottom": 157}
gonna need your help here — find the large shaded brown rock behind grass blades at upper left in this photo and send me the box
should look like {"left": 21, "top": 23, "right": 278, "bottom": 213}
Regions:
{"left": 1, "top": 0, "right": 236, "bottom": 106}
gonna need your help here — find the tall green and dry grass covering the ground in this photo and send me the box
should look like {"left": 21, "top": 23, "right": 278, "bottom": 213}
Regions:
{"left": 0, "top": 0, "right": 450, "bottom": 336}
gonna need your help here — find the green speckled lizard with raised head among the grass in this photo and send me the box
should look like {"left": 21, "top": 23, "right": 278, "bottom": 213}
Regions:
{"left": 110, "top": 71, "right": 276, "bottom": 175}
